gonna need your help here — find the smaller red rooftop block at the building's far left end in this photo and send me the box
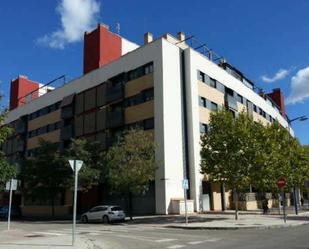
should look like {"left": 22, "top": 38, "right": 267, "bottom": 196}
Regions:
{"left": 10, "top": 76, "right": 39, "bottom": 110}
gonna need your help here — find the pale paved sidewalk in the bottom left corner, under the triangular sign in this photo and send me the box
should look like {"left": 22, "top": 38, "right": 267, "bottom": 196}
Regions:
{"left": 0, "top": 229, "right": 95, "bottom": 249}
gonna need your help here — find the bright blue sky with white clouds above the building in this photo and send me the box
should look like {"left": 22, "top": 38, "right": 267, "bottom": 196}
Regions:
{"left": 0, "top": 0, "right": 309, "bottom": 144}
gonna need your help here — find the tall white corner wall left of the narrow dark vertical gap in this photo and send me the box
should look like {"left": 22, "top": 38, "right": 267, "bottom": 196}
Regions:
{"left": 155, "top": 39, "right": 185, "bottom": 214}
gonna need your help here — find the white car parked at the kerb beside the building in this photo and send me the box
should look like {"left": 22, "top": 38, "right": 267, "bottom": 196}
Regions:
{"left": 81, "top": 206, "right": 126, "bottom": 223}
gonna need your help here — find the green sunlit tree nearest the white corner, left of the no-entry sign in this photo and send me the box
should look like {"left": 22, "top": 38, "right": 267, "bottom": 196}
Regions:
{"left": 201, "top": 110, "right": 255, "bottom": 219}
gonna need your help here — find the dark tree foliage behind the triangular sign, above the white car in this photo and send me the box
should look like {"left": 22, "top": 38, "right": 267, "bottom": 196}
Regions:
{"left": 66, "top": 139, "right": 106, "bottom": 191}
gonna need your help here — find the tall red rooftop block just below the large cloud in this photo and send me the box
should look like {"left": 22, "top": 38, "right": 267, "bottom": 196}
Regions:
{"left": 84, "top": 24, "right": 122, "bottom": 74}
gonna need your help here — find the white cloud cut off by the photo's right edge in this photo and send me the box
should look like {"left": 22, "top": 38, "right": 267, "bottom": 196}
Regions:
{"left": 286, "top": 67, "right": 309, "bottom": 104}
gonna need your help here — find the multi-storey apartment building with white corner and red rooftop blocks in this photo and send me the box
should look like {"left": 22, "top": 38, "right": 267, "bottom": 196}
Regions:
{"left": 3, "top": 24, "right": 288, "bottom": 214}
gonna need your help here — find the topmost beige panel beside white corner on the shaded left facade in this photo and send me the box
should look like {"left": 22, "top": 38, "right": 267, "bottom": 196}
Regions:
{"left": 125, "top": 73, "right": 153, "bottom": 98}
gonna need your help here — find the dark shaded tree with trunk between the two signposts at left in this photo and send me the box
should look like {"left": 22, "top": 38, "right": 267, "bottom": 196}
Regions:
{"left": 21, "top": 140, "right": 72, "bottom": 217}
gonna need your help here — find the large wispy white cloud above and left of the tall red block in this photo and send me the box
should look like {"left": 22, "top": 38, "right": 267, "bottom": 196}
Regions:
{"left": 37, "top": 0, "right": 100, "bottom": 49}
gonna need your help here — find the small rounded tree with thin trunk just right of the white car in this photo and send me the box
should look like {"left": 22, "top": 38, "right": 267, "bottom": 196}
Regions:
{"left": 106, "top": 129, "right": 157, "bottom": 219}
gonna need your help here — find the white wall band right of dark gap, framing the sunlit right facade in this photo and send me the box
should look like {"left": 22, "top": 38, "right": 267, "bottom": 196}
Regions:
{"left": 185, "top": 48, "right": 293, "bottom": 211}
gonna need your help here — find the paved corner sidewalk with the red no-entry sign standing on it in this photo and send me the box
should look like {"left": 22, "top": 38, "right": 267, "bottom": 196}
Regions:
{"left": 127, "top": 211, "right": 309, "bottom": 230}
